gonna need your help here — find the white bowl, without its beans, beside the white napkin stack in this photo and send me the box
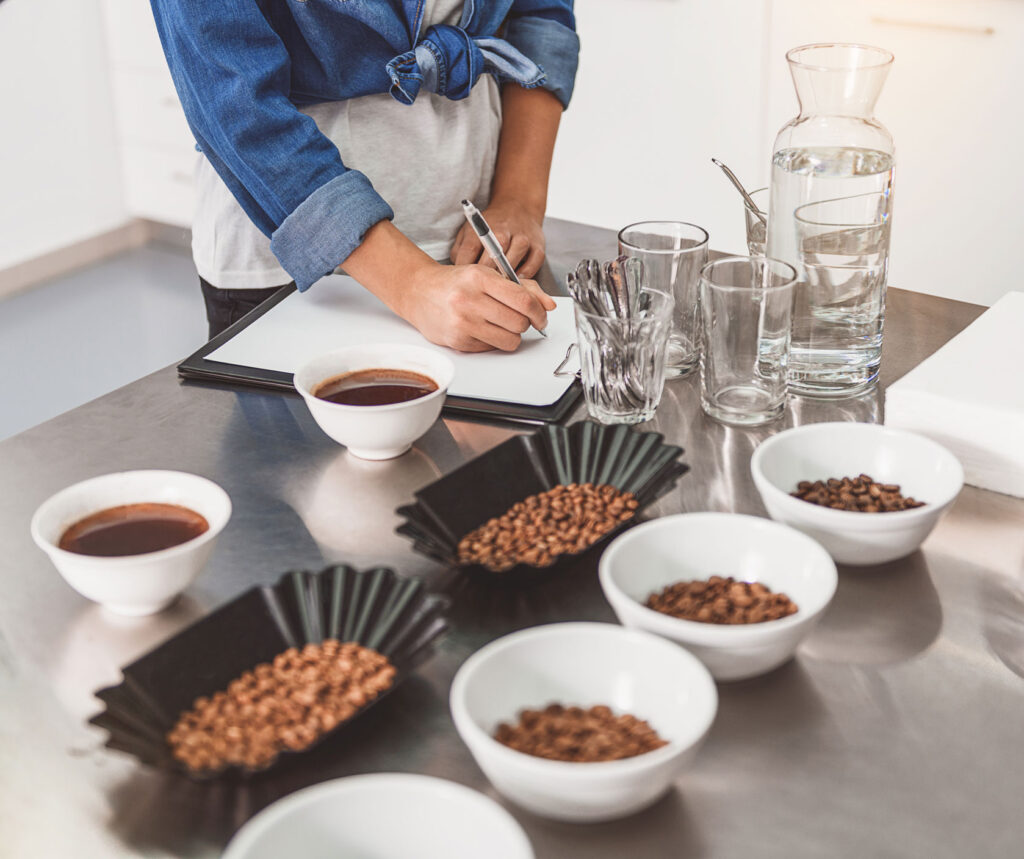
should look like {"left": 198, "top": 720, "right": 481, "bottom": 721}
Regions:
{"left": 751, "top": 423, "right": 964, "bottom": 565}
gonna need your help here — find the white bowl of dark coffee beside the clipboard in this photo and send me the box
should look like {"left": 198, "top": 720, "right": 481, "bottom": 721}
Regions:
{"left": 295, "top": 343, "right": 455, "bottom": 460}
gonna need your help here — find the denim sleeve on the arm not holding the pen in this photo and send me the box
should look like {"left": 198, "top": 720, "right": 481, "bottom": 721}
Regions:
{"left": 504, "top": 0, "right": 580, "bottom": 108}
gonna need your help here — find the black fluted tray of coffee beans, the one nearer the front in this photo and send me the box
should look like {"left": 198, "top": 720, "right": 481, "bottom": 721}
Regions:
{"left": 89, "top": 564, "right": 449, "bottom": 780}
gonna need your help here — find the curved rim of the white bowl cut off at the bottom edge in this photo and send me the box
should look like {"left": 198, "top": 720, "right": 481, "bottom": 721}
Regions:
{"left": 222, "top": 772, "right": 536, "bottom": 859}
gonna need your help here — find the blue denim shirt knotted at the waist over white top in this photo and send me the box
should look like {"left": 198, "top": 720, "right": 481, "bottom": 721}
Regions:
{"left": 152, "top": 0, "right": 580, "bottom": 290}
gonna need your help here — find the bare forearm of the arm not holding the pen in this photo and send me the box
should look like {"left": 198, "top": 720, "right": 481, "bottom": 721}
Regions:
{"left": 490, "top": 84, "right": 562, "bottom": 221}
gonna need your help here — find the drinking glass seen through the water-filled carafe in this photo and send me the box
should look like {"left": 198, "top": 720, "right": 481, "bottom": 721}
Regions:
{"left": 790, "top": 192, "right": 892, "bottom": 397}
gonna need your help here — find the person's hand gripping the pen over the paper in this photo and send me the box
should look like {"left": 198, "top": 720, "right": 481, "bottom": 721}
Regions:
{"left": 399, "top": 264, "right": 555, "bottom": 352}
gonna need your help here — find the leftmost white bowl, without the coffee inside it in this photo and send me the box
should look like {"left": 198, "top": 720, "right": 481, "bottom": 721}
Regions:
{"left": 31, "top": 471, "right": 231, "bottom": 615}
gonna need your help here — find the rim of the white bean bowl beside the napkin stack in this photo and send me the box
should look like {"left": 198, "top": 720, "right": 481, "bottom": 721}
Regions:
{"left": 751, "top": 421, "right": 964, "bottom": 530}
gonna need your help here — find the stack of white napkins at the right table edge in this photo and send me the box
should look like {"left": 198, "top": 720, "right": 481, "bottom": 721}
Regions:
{"left": 886, "top": 292, "right": 1024, "bottom": 498}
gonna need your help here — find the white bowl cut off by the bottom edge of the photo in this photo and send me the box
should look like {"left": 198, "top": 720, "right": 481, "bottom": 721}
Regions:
{"left": 223, "top": 773, "right": 534, "bottom": 859}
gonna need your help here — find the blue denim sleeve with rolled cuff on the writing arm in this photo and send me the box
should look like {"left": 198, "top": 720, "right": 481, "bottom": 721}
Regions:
{"left": 152, "top": 0, "right": 394, "bottom": 290}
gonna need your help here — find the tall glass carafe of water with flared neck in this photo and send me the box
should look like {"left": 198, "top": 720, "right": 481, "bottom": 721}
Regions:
{"left": 767, "top": 44, "right": 895, "bottom": 397}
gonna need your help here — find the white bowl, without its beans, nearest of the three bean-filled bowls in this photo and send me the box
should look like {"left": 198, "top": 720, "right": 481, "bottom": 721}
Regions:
{"left": 450, "top": 624, "right": 718, "bottom": 822}
